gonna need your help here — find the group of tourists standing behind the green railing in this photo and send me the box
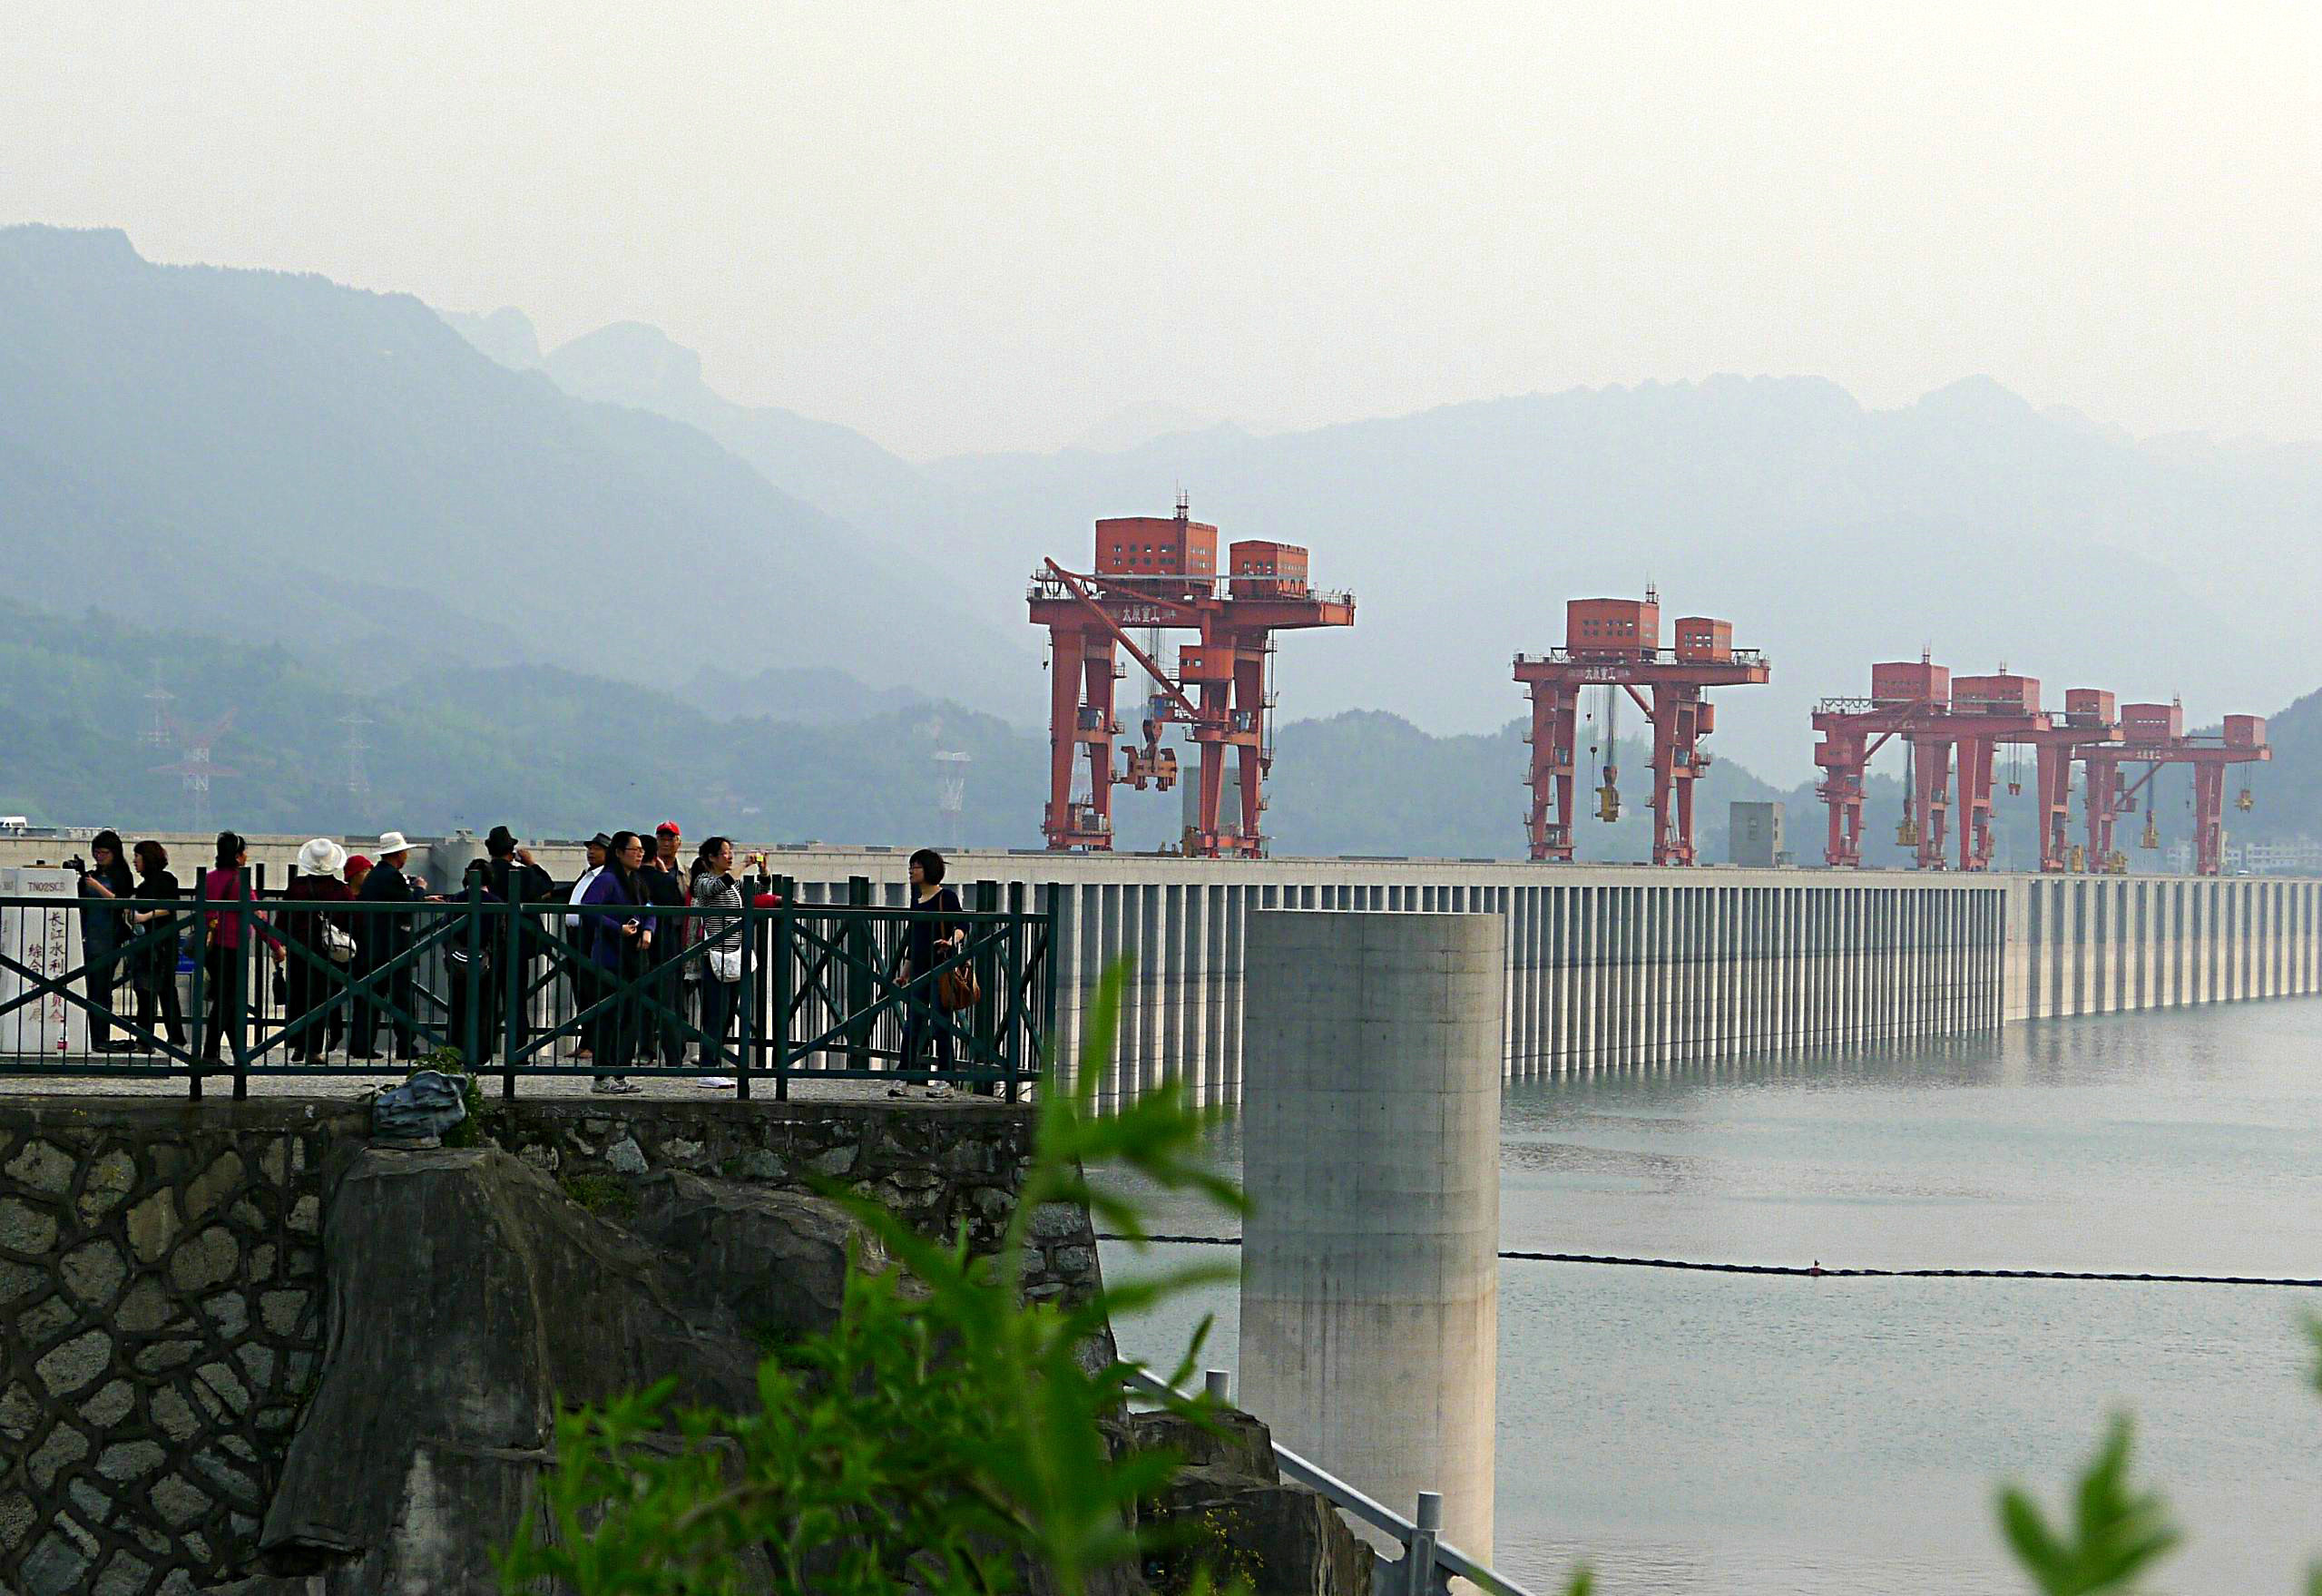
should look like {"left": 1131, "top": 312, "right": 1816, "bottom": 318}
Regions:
{"left": 74, "top": 820, "right": 966, "bottom": 1094}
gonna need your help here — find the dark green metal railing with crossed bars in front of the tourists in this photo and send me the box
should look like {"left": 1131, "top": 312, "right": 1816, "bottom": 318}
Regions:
{"left": 0, "top": 871, "right": 1054, "bottom": 1102}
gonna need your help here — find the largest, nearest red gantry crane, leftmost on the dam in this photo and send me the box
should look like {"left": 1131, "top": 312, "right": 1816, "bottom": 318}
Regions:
{"left": 1029, "top": 506, "right": 1354, "bottom": 857}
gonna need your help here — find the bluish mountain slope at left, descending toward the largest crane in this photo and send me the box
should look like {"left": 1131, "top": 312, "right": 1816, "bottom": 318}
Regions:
{"left": 0, "top": 228, "right": 1019, "bottom": 715}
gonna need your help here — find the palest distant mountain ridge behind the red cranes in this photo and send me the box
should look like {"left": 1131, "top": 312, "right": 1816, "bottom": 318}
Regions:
{"left": 475, "top": 301, "right": 2322, "bottom": 780}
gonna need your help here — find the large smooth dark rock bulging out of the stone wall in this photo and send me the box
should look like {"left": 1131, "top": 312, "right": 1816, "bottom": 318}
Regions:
{"left": 260, "top": 1148, "right": 757, "bottom": 1596}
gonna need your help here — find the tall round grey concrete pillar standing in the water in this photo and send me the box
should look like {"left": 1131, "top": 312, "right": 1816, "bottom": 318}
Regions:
{"left": 1242, "top": 911, "right": 1507, "bottom": 1559}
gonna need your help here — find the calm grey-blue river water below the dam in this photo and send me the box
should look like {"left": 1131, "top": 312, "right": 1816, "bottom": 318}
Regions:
{"left": 1105, "top": 999, "right": 2322, "bottom": 1596}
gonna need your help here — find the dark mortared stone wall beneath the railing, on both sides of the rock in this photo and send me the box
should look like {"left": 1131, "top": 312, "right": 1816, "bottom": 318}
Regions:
{"left": 0, "top": 1097, "right": 1098, "bottom": 1596}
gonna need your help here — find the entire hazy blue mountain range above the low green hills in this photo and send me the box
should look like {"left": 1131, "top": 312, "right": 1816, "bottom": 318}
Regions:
{"left": 0, "top": 228, "right": 2322, "bottom": 859}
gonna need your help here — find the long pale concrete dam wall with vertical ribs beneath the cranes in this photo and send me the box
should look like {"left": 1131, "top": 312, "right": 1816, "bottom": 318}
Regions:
{"left": 773, "top": 848, "right": 2322, "bottom": 1102}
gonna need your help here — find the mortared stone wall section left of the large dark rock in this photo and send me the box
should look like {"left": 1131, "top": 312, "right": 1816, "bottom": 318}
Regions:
{"left": 0, "top": 1099, "right": 360, "bottom": 1596}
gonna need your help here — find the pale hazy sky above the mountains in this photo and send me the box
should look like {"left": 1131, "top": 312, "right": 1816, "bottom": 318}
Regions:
{"left": 0, "top": 0, "right": 2322, "bottom": 455}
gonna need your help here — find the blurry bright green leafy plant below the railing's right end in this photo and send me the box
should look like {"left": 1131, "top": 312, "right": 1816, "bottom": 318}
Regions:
{"left": 502, "top": 969, "right": 1242, "bottom": 1596}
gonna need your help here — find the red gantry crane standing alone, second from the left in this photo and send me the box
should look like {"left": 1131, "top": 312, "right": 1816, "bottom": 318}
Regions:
{"left": 1516, "top": 588, "right": 1772, "bottom": 864}
